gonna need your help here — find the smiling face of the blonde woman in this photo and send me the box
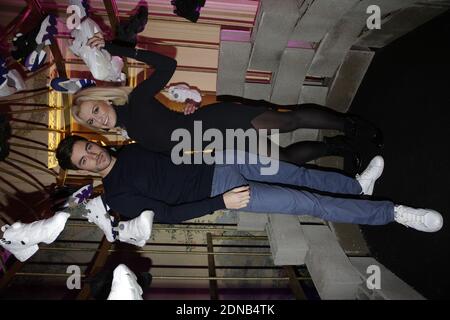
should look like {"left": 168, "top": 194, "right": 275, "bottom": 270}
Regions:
{"left": 78, "top": 100, "right": 117, "bottom": 129}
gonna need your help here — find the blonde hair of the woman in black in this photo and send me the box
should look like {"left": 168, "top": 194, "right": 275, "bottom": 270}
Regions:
{"left": 71, "top": 87, "right": 133, "bottom": 131}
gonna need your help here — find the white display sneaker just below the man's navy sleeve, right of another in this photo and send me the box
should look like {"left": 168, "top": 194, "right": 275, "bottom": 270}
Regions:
{"left": 114, "top": 210, "right": 155, "bottom": 247}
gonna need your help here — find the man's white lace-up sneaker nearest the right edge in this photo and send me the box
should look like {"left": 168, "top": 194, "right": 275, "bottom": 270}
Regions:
{"left": 394, "top": 205, "right": 444, "bottom": 232}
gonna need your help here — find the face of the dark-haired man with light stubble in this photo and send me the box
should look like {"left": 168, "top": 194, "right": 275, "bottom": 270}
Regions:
{"left": 70, "top": 141, "right": 111, "bottom": 173}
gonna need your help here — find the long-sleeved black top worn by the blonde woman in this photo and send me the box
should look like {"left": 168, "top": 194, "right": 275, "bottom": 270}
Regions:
{"left": 105, "top": 42, "right": 268, "bottom": 154}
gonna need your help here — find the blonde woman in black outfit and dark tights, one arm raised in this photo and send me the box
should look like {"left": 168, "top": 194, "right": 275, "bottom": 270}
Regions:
{"left": 72, "top": 34, "right": 381, "bottom": 167}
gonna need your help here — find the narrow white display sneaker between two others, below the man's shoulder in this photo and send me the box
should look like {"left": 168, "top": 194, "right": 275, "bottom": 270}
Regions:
{"left": 85, "top": 196, "right": 115, "bottom": 242}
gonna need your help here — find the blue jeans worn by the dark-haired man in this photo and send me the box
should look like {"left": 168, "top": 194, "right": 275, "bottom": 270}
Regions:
{"left": 211, "top": 151, "right": 394, "bottom": 225}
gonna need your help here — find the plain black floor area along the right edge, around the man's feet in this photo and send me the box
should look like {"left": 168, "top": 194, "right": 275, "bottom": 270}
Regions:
{"left": 346, "top": 11, "right": 450, "bottom": 299}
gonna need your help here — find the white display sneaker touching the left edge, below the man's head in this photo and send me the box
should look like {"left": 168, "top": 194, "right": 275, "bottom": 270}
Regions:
{"left": 0, "top": 211, "right": 70, "bottom": 262}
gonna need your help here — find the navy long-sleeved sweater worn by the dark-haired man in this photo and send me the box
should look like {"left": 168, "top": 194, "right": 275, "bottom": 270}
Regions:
{"left": 103, "top": 144, "right": 225, "bottom": 223}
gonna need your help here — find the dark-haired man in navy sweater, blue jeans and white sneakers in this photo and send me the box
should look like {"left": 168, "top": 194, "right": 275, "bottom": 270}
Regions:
{"left": 56, "top": 136, "right": 443, "bottom": 232}
